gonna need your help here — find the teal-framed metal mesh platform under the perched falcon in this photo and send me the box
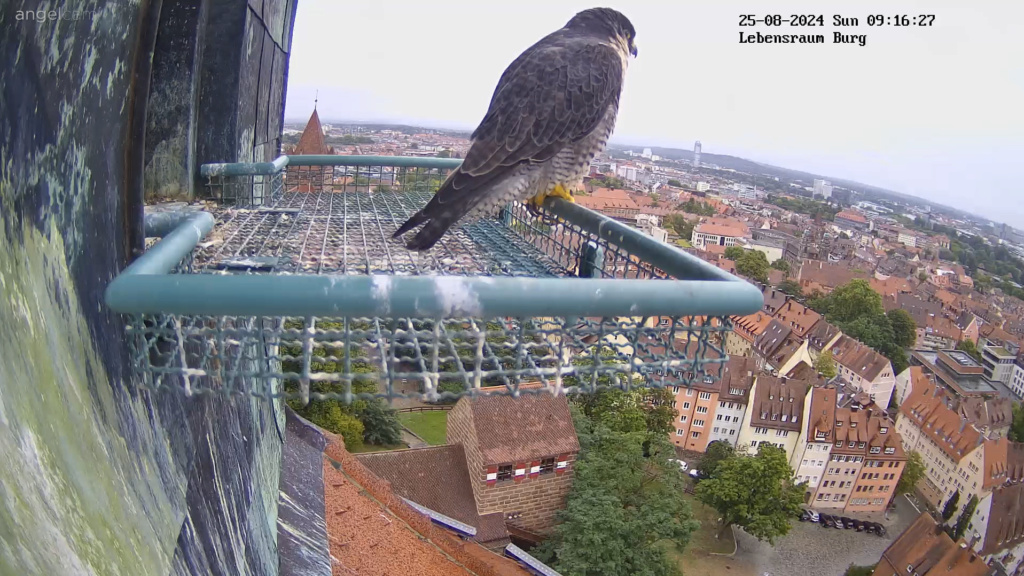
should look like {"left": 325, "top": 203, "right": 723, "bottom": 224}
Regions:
{"left": 108, "top": 157, "right": 760, "bottom": 401}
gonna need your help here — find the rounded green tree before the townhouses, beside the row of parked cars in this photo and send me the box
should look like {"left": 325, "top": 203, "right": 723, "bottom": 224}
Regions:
{"left": 696, "top": 443, "right": 804, "bottom": 543}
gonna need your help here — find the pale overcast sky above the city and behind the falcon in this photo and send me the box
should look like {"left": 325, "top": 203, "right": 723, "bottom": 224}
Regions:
{"left": 286, "top": 0, "right": 1024, "bottom": 228}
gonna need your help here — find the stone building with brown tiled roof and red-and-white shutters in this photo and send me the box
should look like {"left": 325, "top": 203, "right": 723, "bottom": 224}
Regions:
{"left": 356, "top": 386, "right": 580, "bottom": 550}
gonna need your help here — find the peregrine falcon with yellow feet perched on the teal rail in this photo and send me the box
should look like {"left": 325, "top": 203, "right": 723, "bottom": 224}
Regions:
{"left": 393, "top": 8, "right": 637, "bottom": 250}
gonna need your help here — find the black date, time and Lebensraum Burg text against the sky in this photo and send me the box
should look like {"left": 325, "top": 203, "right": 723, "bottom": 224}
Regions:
{"left": 739, "top": 13, "right": 935, "bottom": 46}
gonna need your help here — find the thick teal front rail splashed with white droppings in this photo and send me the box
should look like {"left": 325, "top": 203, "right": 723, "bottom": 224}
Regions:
{"left": 106, "top": 270, "right": 762, "bottom": 318}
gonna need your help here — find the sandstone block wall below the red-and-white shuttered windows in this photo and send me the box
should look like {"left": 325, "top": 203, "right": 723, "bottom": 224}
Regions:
{"left": 474, "top": 455, "right": 575, "bottom": 534}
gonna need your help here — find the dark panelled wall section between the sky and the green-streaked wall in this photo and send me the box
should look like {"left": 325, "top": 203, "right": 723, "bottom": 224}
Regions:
{"left": 145, "top": 0, "right": 296, "bottom": 199}
